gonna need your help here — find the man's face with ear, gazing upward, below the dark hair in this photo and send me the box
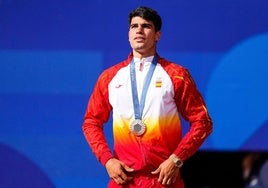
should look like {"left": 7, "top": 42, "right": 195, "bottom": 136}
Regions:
{"left": 128, "top": 17, "right": 161, "bottom": 55}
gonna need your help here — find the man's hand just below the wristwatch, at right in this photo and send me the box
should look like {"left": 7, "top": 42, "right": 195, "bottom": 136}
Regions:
{"left": 152, "top": 159, "right": 180, "bottom": 185}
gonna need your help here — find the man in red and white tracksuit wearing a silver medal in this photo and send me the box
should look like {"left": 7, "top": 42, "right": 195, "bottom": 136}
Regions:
{"left": 83, "top": 7, "right": 212, "bottom": 188}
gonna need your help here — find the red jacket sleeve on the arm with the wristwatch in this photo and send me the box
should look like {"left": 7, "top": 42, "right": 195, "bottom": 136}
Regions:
{"left": 173, "top": 68, "right": 212, "bottom": 161}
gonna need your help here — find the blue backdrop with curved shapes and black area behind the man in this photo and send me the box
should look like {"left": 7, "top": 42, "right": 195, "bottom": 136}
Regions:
{"left": 0, "top": 0, "right": 268, "bottom": 188}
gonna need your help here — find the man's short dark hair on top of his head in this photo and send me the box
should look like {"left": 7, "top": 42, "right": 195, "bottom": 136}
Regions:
{"left": 128, "top": 6, "right": 162, "bottom": 31}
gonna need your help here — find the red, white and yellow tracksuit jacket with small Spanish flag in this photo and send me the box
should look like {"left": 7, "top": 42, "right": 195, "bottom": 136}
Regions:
{"left": 82, "top": 54, "right": 212, "bottom": 185}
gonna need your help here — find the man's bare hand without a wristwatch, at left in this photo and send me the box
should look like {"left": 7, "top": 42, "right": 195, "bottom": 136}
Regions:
{"left": 105, "top": 158, "right": 134, "bottom": 185}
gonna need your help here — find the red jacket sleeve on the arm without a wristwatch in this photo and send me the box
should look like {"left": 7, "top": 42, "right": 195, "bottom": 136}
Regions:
{"left": 82, "top": 72, "right": 113, "bottom": 165}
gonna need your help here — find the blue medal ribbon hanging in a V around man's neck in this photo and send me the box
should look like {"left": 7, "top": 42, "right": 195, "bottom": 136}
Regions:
{"left": 130, "top": 56, "right": 157, "bottom": 120}
